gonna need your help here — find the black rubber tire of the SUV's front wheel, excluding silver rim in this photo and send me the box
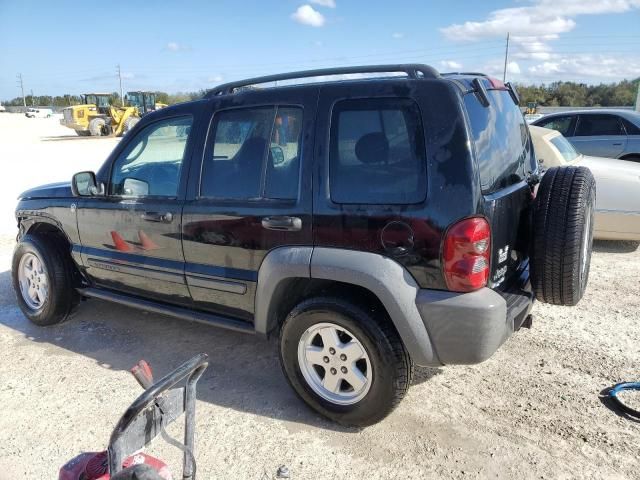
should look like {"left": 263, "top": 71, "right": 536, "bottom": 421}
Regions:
{"left": 11, "top": 234, "right": 80, "bottom": 326}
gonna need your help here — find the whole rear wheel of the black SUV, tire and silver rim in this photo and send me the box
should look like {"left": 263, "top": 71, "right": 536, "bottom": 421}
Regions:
{"left": 280, "top": 297, "right": 413, "bottom": 427}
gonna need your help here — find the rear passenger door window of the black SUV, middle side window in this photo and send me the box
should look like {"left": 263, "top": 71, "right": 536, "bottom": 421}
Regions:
{"left": 200, "top": 106, "right": 302, "bottom": 200}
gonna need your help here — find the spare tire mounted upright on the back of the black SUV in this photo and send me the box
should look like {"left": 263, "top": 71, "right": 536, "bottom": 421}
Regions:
{"left": 531, "top": 166, "right": 596, "bottom": 306}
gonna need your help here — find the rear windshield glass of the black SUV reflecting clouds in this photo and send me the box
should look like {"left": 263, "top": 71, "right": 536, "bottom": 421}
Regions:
{"left": 464, "top": 90, "right": 536, "bottom": 194}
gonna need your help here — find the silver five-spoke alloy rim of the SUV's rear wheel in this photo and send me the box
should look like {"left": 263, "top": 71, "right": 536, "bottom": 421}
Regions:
{"left": 298, "top": 322, "right": 373, "bottom": 405}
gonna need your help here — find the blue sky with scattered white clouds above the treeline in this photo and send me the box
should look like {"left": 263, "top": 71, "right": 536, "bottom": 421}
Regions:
{"left": 0, "top": 0, "right": 640, "bottom": 99}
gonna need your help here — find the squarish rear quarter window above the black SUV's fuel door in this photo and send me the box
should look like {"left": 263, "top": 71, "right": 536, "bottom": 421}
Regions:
{"left": 329, "top": 98, "right": 427, "bottom": 204}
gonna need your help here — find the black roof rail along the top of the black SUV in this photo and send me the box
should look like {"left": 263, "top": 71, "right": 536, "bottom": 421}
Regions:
{"left": 205, "top": 63, "right": 440, "bottom": 98}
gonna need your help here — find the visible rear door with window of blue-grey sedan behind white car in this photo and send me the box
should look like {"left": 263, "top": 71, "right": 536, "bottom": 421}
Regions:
{"left": 571, "top": 114, "right": 627, "bottom": 158}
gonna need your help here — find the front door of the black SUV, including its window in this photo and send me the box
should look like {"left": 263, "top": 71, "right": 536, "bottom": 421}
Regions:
{"left": 78, "top": 116, "right": 193, "bottom": 304}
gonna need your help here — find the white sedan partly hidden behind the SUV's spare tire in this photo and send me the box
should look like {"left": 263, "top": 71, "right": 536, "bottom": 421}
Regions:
{"left": 529, "top": 125, "right": 640, "bottom": 241}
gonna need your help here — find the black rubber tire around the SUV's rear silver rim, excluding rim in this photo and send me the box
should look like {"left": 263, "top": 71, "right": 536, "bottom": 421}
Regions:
{"left": 280, "top": 297, "right": 413, "bottom": 427}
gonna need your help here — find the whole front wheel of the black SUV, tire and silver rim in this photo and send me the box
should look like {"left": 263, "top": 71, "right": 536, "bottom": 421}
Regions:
{"left": 11, "top": 235, "right": 79, "bottom": 326}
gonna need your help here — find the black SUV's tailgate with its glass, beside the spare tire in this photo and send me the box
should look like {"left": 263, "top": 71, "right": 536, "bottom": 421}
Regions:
{"left": 464, "top": 89, "right": 537, "bottom": 288}
